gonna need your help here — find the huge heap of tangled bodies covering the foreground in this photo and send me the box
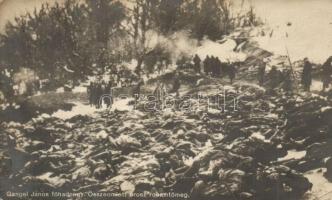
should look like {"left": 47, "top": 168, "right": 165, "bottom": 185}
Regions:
{"left": 0, "top": 81, "right": 320, "bottom": 200}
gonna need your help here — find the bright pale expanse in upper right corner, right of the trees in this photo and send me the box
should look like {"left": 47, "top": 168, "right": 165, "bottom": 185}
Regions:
{"left": 251, "top": 0, "right": 332, "bottom": 63}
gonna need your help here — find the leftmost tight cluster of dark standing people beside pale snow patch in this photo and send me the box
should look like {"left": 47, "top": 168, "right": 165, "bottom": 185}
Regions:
{"left": 87, "top": 81, "right": 113, "bottom": 108}
